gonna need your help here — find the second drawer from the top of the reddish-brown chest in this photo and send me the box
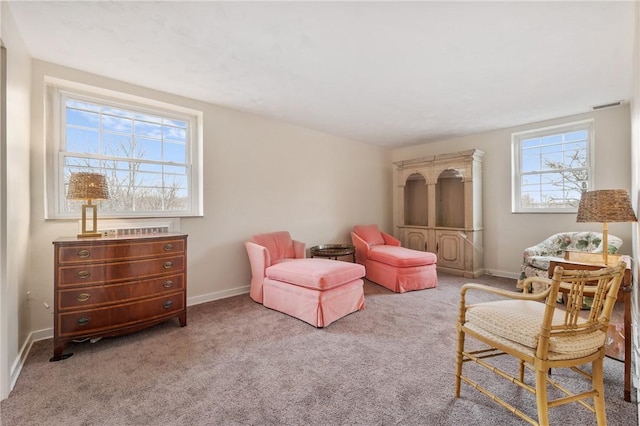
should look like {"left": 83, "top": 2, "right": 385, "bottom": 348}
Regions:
{"left": 57, "top": 256, "right": 185, "bottom": 287}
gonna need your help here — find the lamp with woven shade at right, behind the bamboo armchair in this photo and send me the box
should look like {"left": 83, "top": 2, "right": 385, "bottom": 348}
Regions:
{"left": 576, "top": 189, "right": 637, "bottom": 265}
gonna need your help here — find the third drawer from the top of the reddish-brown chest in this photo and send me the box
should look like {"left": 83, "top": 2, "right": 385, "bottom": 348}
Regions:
{"left": 58, "top": 274, "right": 185, "bottom": 311}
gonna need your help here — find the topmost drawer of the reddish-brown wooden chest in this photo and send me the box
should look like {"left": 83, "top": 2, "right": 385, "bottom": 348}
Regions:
{"left": 58, "top": 239, "right": 185, "bottom": 264}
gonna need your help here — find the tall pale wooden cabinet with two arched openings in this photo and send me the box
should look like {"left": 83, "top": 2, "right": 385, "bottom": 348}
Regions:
{"left": 393, "top": 149, "right": 484, "bottom": 278}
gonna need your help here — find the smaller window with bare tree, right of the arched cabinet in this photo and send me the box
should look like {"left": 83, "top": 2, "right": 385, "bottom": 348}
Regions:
{"left": 512, "top": 121, "right": 593, "bottom": 212}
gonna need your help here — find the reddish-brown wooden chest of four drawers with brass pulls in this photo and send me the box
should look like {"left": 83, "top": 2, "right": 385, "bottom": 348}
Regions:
{"left": 51, "top": 233, "right": 187, "bottom": 361}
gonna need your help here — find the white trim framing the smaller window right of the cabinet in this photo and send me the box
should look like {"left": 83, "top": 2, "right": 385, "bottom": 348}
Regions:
{"left": 511, "top": 119, "right": 595, "bottom": 214}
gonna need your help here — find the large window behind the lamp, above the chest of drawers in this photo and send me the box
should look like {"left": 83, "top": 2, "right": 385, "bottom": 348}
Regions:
{"left": 52, "top": 87, "right": 199, "bottom": 217}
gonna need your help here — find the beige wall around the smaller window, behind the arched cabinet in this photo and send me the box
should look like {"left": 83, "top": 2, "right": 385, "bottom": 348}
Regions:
{"left": 392, "top": 105, "right": 632, "bottom": 278}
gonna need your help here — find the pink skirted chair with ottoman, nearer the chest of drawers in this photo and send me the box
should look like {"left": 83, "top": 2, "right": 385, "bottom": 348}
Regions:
{"left": 245, "top": 231, "right": 365, "bottom": 327}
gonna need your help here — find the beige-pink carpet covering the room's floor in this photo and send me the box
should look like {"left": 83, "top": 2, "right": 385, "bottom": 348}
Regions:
{"left": 0, "top": 274, "right": 638, "bottom": 426}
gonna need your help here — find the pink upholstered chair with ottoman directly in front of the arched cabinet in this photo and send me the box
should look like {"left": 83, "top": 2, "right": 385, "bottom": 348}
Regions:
{"left": 351, "top": 225, "right": 438, "bottom": 293}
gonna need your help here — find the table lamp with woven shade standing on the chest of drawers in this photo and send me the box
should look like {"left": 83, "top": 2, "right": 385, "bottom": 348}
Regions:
{"left": 67, "top": 172, "right": 109, "bottom": 238}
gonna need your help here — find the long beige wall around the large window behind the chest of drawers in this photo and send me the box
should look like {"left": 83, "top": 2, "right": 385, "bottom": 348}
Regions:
{"left": 29, "top": 60, "right": 392, "bottom": 334}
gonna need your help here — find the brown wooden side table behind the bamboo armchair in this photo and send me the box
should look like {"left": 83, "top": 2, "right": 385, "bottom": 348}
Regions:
{"left": 548, "top": 256, "right": 633, "bottom": 401}
